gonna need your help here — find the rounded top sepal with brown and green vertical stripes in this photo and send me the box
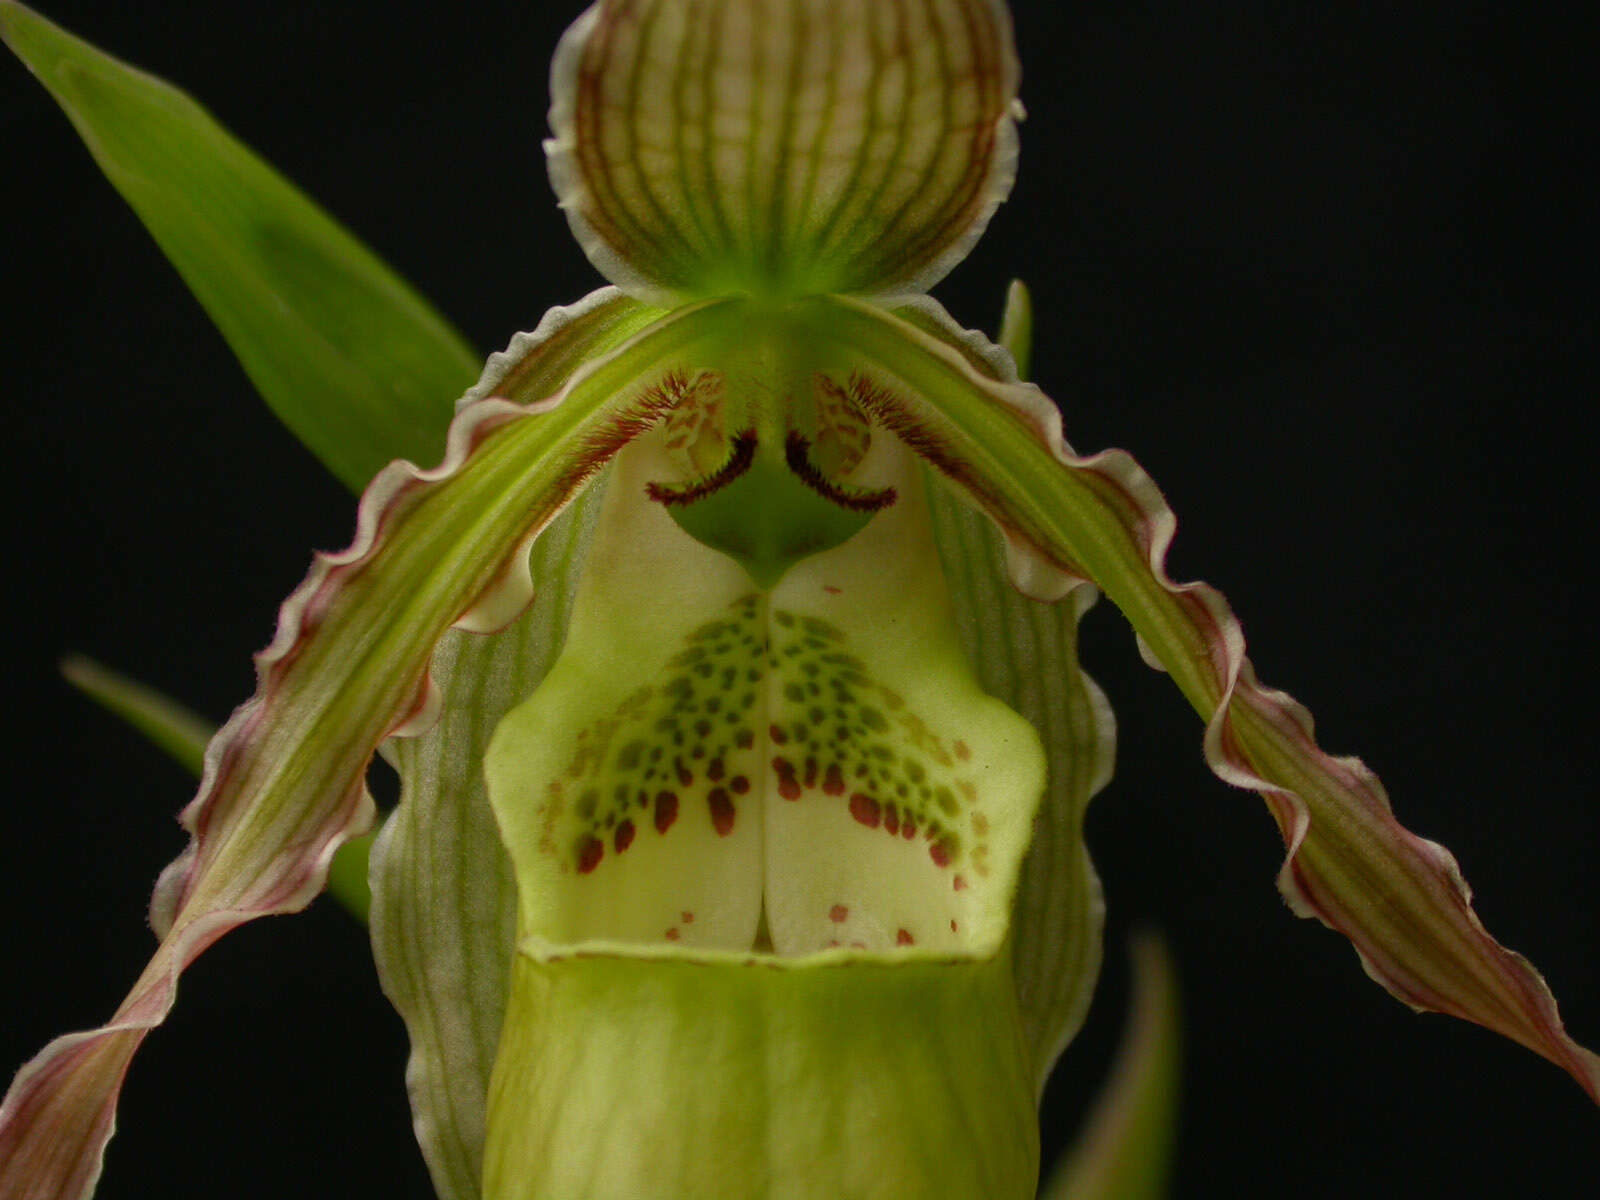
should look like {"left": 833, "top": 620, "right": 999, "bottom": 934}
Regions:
{"left": 546, "top": 0, "right": 1018, "bottom": 301}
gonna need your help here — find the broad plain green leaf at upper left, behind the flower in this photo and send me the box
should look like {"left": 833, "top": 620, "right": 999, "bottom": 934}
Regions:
{"left": 0, "top": 0, "right": 478, "bottom": 490}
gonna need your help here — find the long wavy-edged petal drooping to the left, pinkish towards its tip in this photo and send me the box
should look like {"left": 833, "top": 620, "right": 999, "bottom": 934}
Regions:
{"left": 0, "top": 304, "right": 736, "bottom": 1200}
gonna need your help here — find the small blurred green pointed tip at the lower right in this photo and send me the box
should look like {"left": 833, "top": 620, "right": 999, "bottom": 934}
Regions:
{"left": 1042, "top": 936, "right": 1179, "bottom": 1200}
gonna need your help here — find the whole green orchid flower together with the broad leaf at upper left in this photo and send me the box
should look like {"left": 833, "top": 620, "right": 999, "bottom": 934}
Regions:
{"left": 0, "top": 0, "right": 1600, "bottom": 1200}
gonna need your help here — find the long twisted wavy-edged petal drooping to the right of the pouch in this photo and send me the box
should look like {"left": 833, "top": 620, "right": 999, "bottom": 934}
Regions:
{"left": 813, "top": 298, "right": 1600, "bottom": 1101}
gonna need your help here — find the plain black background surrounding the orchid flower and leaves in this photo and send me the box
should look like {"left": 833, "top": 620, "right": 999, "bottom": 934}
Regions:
{"left": 0, "top": 0, "right": 1600, "bottom": 1200}
